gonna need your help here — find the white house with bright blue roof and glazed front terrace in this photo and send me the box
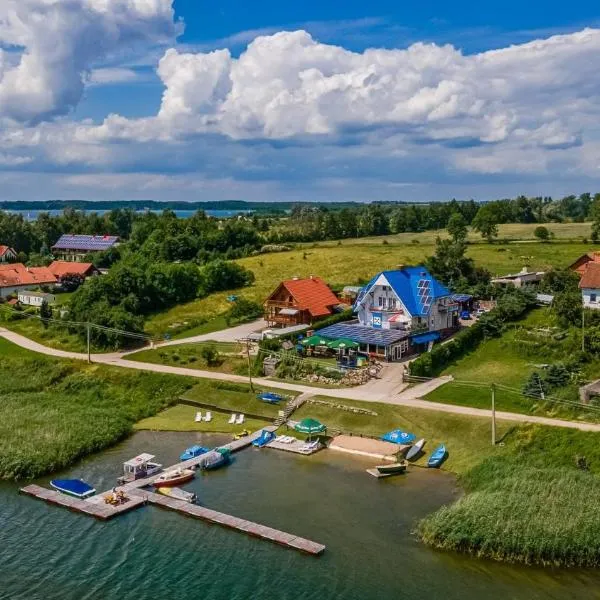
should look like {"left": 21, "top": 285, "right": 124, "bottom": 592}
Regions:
{"left": 318, "top": 266, "right": 460, "bottom": 361}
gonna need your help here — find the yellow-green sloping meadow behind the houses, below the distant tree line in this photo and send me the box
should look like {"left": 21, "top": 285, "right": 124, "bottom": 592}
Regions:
{"left": 146, "top": 236, "right": 593, "bottom": 337}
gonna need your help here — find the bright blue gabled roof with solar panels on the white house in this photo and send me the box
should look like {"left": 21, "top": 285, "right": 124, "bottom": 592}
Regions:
{"left": 355, "top": 266, "right": 450, "bottom": 316}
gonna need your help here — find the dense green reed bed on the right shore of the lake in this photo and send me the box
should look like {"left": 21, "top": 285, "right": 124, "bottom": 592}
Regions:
{"left": 418, "top": 427, "right": 600, "bottom": 567}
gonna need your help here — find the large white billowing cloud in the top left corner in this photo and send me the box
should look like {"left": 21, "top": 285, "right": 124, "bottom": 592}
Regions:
{"left": 0, "top": 0, "right": 177, "bottom": 122}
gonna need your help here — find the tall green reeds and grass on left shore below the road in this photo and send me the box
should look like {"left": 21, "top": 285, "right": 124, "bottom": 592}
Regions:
{"left": 0, "top": 340, "right": 193, "bottom": 479}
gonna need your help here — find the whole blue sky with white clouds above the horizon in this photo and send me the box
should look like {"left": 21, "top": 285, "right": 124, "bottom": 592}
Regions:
{"left": 0, "top": 0, "right": 600, "bottom": 201}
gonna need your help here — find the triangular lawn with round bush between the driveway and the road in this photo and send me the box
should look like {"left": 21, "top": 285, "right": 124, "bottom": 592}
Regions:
{"left": 127, "top": 342, "right": 248, "bottom": 375}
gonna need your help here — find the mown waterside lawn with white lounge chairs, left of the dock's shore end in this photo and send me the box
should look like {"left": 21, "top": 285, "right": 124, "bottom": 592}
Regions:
{"left": 135, "top": 404, "right": 271, "bottom": 433}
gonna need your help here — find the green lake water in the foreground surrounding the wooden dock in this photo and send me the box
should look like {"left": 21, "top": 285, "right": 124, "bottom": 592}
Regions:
{"left": 0, "top": 432, "right": 600, "bottom": 600}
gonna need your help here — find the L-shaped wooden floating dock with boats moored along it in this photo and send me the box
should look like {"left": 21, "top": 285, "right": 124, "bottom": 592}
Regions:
{"left": 20, "top": 428, "right": 325, "bottom": 556}
